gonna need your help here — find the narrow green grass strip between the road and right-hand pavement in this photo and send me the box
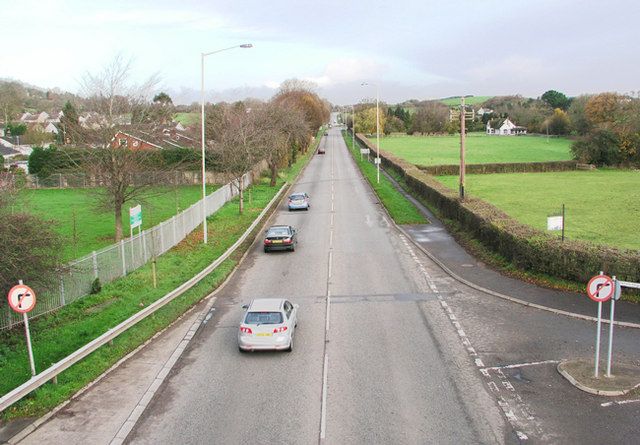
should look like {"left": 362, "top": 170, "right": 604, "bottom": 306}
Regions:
{"left": 342, "top": 131, "right": 428, "bottom": 224}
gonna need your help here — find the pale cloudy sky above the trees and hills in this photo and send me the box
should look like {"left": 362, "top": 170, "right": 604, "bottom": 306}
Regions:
{"left": 0, "top": 0, "right": 640, "bottom": 105}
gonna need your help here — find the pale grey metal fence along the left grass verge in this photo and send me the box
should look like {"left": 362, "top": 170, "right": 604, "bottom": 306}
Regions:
{"left": 0, "top": 173, "right": 253, "bottom": 330}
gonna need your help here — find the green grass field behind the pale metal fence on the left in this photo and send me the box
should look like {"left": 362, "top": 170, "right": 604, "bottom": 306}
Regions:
{"left": 16, "top": 186, "right": 217, "bottom": 260}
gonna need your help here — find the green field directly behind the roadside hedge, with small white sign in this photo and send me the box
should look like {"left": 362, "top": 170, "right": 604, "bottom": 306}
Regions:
{"left": 437, "top": 169, "right": 640, "bottom": 250}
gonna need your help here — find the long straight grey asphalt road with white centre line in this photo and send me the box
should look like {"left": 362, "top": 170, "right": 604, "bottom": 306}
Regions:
{"left": 128, "top": 129, "right": 504, "bottom": 444}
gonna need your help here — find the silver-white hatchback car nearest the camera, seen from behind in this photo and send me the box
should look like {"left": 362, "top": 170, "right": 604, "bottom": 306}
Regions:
{"left": 238, "top": 298, "right": 298, "bottom": 351}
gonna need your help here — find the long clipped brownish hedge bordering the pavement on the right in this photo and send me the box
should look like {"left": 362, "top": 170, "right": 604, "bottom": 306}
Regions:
{"left": 356, "top": 134, "right": 640, "bottom": 282}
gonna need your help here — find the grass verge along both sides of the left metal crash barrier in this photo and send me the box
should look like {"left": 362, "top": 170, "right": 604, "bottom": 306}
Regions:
{"left": 0, "top": 129, "right": 321, "bottom": 422}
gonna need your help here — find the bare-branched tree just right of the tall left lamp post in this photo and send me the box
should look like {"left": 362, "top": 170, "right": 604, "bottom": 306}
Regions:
{"left": 211, "top": 107, "right": 262, "bottom": 213}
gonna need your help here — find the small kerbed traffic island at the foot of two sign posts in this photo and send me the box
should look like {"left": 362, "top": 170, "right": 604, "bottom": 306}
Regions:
{"left": 557, "top": 359, "right": 640, "bottom": 397}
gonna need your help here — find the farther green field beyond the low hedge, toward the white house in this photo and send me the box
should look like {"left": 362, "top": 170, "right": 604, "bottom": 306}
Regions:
{"left": 380, "top": 133, "right": 572, "bottom": 165}
